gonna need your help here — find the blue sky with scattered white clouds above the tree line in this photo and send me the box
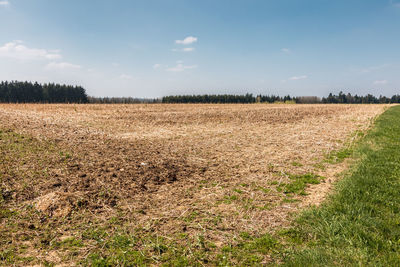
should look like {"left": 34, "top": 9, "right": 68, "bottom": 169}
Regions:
{"left": 0, "top": 0, "right": 400, "bottom": 98}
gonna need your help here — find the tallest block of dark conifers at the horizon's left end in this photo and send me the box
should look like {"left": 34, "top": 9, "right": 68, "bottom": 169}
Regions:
{"left": 0, "top": 81, "right": 88, "bottom": 103}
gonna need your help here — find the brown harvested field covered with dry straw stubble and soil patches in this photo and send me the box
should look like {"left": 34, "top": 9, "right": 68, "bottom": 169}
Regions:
{"left": 0, "top": 104, "right": 387, "bottom": 265}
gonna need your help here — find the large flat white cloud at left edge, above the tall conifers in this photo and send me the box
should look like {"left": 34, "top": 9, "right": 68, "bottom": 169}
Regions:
{"left": 0, "top": 41, "right": 62, "bottom": 60}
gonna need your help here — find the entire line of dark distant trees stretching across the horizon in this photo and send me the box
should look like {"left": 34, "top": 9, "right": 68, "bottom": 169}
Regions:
{"left": 0, "top": 81, "right": 400, "bottom": 104}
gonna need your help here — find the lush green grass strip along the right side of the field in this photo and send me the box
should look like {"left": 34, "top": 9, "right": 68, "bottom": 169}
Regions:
{"left": 282, "top": 106, "right": 400, "bottom": 266}
